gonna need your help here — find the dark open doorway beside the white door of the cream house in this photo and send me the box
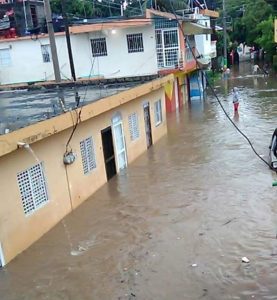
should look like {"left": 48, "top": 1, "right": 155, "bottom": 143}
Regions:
{"left": 101, "top": 126, "right": 116, "bottom": 180}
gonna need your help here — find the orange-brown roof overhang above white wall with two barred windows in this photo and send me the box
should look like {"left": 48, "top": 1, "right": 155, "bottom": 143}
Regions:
{"left": 69, "top": 19, "right": 151, "bottom": 34}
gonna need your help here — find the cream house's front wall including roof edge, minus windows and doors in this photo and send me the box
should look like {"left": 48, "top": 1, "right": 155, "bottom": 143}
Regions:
{"left": 0, "top": 76, "right": 171, "bottom": 265}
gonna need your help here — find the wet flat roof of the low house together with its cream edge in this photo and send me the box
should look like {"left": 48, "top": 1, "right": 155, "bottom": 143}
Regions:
{"left": 0, "top": 74, "right": 174, "bottom": 156}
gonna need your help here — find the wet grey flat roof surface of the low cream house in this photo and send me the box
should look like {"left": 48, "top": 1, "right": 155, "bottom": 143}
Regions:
{"left": 0, "top": 82, "right": 141, "bottom": 135}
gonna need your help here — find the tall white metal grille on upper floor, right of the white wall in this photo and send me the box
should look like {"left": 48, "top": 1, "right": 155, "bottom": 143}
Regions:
{"left": 156, "top": 29, "right": 180, "bottom": 68}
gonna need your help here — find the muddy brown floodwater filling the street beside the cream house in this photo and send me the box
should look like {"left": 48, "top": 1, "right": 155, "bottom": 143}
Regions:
{"left": 0, "top": 65, "right": 277, "bottom": 300}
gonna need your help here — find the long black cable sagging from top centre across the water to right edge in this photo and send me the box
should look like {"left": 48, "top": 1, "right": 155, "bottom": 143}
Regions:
{"left": 169, "top": 0, "right": 276, "bottom": 172}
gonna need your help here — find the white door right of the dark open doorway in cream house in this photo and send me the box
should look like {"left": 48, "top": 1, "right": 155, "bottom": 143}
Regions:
{"left": 112, "top": 113, "right": 127, "bottom": 170}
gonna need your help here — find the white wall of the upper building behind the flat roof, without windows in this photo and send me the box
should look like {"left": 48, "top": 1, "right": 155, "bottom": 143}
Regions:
{"left": 0, "top": 25, "right": 157, "bottom": 84}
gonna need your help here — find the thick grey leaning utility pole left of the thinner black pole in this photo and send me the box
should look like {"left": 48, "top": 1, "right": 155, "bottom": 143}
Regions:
{"left": 44, "top": 0, "right": 61, "bottom": 83}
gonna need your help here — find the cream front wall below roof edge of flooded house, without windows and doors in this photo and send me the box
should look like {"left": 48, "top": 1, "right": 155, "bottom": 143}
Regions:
{"left": 0, "top": 88, "right": 167, "bottom": 263}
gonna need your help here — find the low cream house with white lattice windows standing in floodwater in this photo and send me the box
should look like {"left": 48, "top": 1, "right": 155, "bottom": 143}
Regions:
{"left": 0, "top": 75, "right": 173, "bottom": 266}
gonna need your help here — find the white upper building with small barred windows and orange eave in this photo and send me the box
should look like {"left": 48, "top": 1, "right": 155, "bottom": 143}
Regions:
{"left": 0, "top": 19, "right": 158, "bottom": 84}
